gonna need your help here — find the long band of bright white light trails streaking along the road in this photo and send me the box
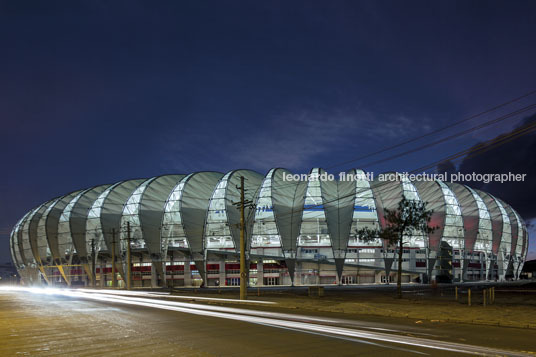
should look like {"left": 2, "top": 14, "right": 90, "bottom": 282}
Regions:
{"left": 0, "top": 287, "right": 532, "bottom": 356}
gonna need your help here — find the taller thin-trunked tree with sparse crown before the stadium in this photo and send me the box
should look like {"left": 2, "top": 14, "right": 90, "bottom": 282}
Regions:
{"left": 357, "top": 197, "right": 438, "bottom": 298}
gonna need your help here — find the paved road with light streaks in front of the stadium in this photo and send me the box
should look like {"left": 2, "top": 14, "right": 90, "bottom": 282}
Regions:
{"left": 0, "top": 288, "right": 535, "bottom": 356}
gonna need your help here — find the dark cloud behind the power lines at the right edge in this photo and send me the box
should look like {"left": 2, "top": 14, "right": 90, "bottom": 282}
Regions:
{"left": 459, "top": 115, "right": 536, "bottom": 220}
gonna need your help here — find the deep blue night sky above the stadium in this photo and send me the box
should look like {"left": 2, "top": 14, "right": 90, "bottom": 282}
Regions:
{"left": 0, "top": 0, "right": 536, "bottom": 262}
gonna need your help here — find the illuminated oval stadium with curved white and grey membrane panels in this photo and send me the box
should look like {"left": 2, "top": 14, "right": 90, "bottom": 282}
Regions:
{"left": 10, "top": 168, "right": 528, "bottom": 287}
